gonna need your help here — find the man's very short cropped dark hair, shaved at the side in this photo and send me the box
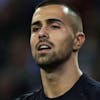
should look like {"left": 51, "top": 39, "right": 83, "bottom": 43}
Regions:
{"left": 35, "top": 0, "right": 83, "bottom": 33}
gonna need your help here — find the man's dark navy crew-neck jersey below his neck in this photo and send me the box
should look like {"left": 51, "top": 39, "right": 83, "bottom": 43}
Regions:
{"left": 16, "top": 74, "right": 100, "bottom": 100}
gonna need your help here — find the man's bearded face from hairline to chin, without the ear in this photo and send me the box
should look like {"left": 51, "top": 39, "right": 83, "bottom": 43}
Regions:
{"left": 30, "top": 5, "right": 74, "bottom": 65}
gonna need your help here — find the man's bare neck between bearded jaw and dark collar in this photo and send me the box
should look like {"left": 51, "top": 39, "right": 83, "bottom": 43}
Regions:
{"left": 40, "top": 53, "right": 82, "bottom": 98}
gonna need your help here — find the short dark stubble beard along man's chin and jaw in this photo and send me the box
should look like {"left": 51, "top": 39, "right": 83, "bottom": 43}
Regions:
{"left": 35, "top": 44, "right": 73, "bottom": 72}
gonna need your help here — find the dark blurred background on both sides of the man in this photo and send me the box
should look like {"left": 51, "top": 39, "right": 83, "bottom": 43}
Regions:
{"left": 0, "top": 0, "right": 100, "bottom": 100}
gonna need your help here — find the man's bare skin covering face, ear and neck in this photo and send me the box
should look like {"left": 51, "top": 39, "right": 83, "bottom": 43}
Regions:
{"left": 30, "top": 4, "right": 85, "bottom": 98}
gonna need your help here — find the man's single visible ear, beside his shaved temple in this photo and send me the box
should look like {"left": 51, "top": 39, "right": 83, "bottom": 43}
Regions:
{"left": 73, "top": 32, "right": 85, "bottom": 51}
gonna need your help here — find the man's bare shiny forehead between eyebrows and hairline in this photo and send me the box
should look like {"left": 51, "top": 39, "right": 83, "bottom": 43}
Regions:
{"left": 32, "top": 4, "right": 69, "bottom": 22}
